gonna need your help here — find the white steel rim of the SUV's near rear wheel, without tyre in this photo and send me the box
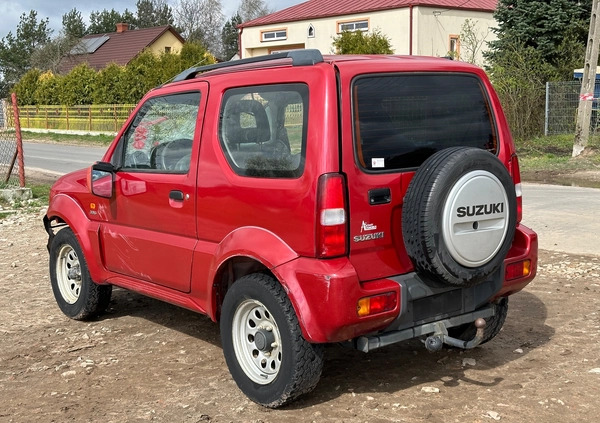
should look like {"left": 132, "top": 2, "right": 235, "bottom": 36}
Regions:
{"left": 231, "top": 300, "right": 282, "bottom": 385}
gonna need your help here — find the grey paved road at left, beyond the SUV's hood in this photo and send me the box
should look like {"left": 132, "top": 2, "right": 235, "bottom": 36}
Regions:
{"left": 23, "top": 142, "right": 107, "bottom": 175}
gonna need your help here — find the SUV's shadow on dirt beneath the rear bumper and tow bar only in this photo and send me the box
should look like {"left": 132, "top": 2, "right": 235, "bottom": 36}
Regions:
{"left": 288, "top": 292, "right": 555, "bottom": 409}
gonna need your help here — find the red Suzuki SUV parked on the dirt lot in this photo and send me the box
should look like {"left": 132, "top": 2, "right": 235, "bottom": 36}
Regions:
{"left": 44, "top": 50, "right": 537, "bottom": 407}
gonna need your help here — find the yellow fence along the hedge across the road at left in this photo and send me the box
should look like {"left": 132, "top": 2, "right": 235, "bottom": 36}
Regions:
{"left": 7, "top": 104, "right": 135, "bottom": 133}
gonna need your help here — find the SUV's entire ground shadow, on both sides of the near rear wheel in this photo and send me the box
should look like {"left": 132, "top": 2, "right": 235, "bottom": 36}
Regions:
{"left": 94, "top": 288, "right": 555, "bottom": 410}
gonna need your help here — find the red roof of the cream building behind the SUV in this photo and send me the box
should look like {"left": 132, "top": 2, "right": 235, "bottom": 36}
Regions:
{"left": 240, "top": 0, "right": 498, "bottom": 27}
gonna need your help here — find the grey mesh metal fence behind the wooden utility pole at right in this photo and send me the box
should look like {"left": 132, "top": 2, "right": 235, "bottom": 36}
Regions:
{"left": 544, "top": 81, "right": 600, "bottom": 135}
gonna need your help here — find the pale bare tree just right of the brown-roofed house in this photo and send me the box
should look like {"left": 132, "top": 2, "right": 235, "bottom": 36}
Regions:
{"left": 175, "top": 0, "right": 225, "bottom": 56}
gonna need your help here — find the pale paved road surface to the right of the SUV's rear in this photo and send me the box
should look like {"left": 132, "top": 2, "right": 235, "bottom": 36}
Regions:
{"left": 523, "top": 184, "right": 600, "bottom": 255}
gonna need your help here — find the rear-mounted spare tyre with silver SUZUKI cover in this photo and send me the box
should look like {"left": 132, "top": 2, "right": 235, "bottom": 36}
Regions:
{"left": 402, "top": 147, "right": 517, "bottom": 287}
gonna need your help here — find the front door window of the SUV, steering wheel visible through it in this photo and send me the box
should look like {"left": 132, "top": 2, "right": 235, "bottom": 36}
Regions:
{"left": 122, "top": 92, "right": 200, "bottom": 173}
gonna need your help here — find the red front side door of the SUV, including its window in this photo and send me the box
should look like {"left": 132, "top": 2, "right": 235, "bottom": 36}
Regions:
{"left": 101, "top": 83, "right": 208, "bottom": 292}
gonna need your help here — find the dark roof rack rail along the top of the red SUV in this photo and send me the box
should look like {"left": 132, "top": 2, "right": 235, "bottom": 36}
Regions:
{"left": 172, "top": 49, "right": 323, "bottom": 82}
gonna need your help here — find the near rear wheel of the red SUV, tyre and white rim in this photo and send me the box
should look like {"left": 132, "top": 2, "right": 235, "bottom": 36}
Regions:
{"left": 220, "top": 273, "right": 323, "bottom": 408}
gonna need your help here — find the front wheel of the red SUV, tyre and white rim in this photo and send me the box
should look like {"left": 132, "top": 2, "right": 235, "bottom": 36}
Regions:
{"left": 50, "top": 228, "right": 112, "bottom": 320}
